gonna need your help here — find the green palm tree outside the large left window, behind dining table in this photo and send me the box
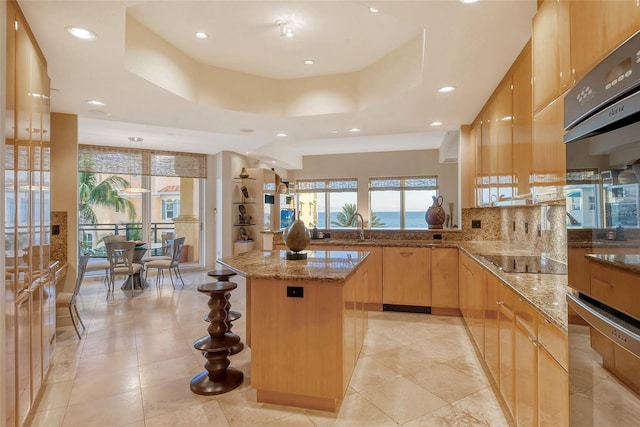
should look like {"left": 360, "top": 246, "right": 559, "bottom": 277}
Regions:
{"left": 78, "top": 172, "right": 136, "bottom": 224}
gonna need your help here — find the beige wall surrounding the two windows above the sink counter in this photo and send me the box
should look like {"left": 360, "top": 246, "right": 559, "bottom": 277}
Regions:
{"left": 288, "top": 149, "right": 460, "bottom": 223}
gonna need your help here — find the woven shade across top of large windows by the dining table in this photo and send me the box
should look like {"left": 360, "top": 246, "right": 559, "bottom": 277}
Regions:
{"left": 78, "top": 145, "right": 207, "bottom": 178}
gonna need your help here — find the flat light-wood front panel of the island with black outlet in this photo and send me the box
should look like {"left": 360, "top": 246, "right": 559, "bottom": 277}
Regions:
{"left": 250, "top": 279, "right": 345, "bottom": 410}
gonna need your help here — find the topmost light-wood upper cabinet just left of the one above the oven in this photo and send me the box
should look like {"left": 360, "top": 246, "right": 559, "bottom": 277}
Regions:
{"left": 531, "top": 0, "right": 568, "bottom": 112}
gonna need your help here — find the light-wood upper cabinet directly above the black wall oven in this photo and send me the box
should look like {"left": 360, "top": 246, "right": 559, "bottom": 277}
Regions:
{"left": 570, "top": 0, "right": 640, "bottom": 81}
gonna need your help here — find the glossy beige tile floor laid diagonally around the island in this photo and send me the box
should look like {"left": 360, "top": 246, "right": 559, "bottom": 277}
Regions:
{"left": 31, "top": 271, "right": 510, "bottom": 427}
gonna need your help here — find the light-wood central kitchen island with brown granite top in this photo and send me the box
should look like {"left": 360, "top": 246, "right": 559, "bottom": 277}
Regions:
{"left": 218, "top": 250, "right": 369, "bottom": 412}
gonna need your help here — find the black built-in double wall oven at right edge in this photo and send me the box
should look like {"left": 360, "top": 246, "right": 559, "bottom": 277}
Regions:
{"left": 564, "top": 32, "right": 640, "bottom": 427}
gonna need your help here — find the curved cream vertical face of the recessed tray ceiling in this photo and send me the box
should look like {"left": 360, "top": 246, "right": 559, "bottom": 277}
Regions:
{"left": 125, "top": 13, "right": 424, "bottom": 117}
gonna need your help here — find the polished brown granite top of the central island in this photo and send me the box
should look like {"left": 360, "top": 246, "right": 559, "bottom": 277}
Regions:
{"left": 218, "top": 250, "right": 369, "bottom": 282}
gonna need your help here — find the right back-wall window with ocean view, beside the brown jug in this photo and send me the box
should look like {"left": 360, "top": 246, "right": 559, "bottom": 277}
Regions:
{"left": 369, "top": 176, "right": 438, "bottom": 230}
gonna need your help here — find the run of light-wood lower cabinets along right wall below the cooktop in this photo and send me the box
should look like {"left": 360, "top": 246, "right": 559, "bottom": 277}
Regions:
{"left": 458, "top": 251, "right": 569, "bottom": 427}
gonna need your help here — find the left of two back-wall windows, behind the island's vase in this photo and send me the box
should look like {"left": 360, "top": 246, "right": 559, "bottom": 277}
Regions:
{"left": 296, "top": 178, "right": 358, "bottom": 229}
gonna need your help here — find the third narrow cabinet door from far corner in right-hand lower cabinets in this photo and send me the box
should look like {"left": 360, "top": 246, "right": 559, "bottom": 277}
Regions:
{"left": 484, "top": 271, "right": 501, "bottom": 384}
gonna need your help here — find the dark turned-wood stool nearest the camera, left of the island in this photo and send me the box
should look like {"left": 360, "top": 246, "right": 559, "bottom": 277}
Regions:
{"left": 190, "top": 281, "right": 244, "bottom": 395}
